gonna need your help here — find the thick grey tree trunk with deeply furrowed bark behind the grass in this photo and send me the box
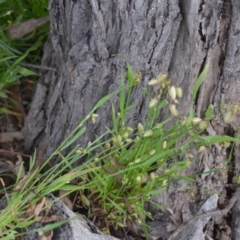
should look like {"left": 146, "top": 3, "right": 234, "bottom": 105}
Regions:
{"left": 24, "top": 0, "right": 240, "bottom": 239}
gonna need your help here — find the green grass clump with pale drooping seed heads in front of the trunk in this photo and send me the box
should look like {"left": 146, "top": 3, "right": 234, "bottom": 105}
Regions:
{"left": 0, "top": 64, "right": 236, "bottom": 239}
